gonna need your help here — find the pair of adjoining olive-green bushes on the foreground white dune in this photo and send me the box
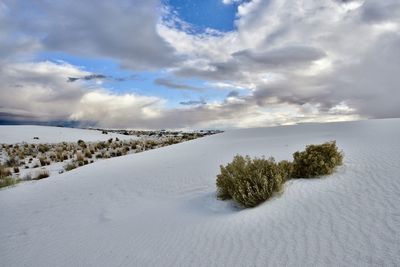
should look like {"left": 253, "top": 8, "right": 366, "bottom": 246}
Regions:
{"left": 217, "top": 141, "right": 343, "bottom": 207}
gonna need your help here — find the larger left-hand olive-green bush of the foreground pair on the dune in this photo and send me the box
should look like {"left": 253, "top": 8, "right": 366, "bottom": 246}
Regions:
{"left": 217, "top": 155, "right": 285, "bottom": 207}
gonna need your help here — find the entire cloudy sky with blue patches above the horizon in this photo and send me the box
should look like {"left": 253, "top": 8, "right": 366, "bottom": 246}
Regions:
{"left": 0, "top": 0, "right": 400, "bottom": 129}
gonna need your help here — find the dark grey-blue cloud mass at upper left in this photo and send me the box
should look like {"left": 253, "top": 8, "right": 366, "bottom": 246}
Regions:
{"left": 5, "top": 0, "right": 176, "bottom": 70}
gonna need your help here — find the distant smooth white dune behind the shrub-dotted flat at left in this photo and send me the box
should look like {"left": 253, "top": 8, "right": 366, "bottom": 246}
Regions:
{"left": 0, "top": 125, "right": 134, "bottom": 144}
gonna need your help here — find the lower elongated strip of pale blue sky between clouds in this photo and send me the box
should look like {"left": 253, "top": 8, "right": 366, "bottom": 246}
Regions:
{"left": 36, "top": 52, "right": 233, "bottom": 108}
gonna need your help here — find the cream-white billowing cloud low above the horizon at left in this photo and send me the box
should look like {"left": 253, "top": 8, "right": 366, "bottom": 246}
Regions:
{"left": 0, "top": 62, "right": 163, "bottom": 127}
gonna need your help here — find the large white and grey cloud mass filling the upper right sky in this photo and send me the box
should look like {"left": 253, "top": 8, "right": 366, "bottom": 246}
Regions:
{"left": 160, "top": 0, "right": 400, "bottom": 121}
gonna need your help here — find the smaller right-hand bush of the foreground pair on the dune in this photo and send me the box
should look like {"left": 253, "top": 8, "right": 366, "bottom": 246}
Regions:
{"left": 292, "top": 141, "right": 343, "bottom": 178}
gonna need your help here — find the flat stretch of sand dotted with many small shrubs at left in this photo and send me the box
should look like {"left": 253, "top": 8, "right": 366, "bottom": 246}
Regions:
{"left": 0, "top": 130, "right": 218, "bottom": 187}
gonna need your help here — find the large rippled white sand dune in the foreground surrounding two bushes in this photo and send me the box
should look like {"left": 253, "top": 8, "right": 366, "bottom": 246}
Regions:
{"left": 0, "top": 119, "right": 400, "bottom": 266}
